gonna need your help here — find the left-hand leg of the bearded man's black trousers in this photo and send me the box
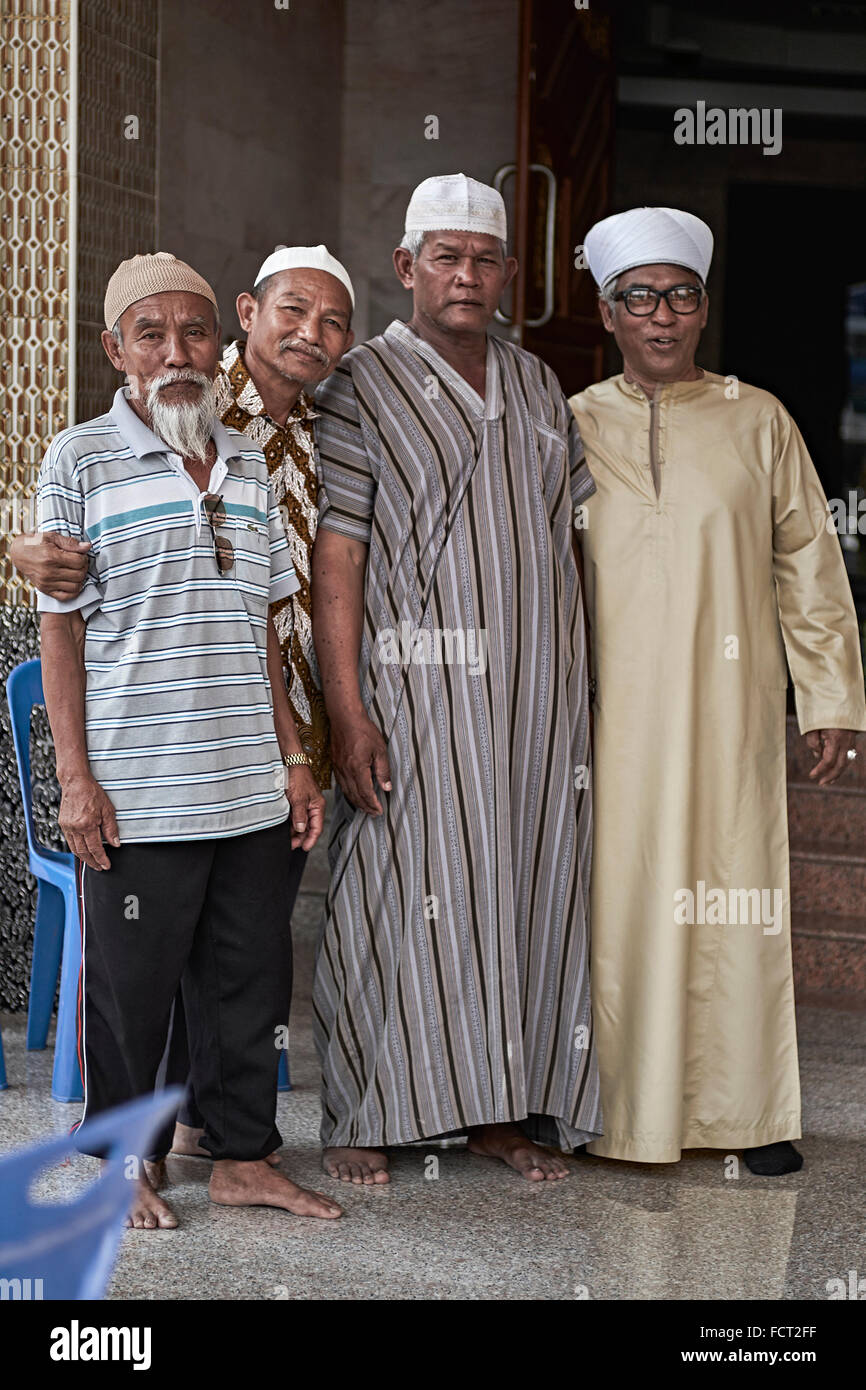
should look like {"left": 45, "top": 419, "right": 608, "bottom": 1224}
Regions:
{"left": 75, "top": 841, "right": 213, "bottom": 1156}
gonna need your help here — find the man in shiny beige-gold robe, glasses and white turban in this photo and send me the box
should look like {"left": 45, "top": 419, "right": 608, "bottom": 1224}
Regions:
{"left": 570, "top": 209, "right": 866, "bottom": 1175}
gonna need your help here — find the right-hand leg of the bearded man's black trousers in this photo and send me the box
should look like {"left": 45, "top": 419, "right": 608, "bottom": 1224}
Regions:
{"left": 183, "top": 823, "right": 292, "bottom": 1161}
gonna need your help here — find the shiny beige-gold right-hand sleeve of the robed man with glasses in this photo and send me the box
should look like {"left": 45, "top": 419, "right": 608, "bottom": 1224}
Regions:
{"left": 773, "top": 409, "right": 866, "bottom": 734}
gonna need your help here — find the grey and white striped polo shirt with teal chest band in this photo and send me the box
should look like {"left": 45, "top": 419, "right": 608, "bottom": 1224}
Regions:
{"left": 39, "top": 389, "right": 299, "bottom": 842}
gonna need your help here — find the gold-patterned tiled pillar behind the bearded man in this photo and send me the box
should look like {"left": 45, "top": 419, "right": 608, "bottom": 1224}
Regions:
{"left": 0, "top": 0, "right": 158, "bottom": 605}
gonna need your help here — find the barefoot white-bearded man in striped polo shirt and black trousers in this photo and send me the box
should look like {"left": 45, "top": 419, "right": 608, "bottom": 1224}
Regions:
{"left": 39, "top": 253, "right": 341, "bottom": 1227}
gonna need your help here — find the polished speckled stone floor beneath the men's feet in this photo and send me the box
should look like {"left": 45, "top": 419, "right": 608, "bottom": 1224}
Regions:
{"left": 0, "top": 817, "right": 866, "bottom": 1300}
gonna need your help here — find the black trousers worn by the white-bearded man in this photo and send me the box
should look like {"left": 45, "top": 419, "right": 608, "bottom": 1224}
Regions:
{"left": 75, "top": 821, "right": 301, "bottom": 1159}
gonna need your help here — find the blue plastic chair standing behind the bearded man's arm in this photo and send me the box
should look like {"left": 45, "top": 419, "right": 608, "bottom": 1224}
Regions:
{"left": 6, "top": 660, "right": 85, "bottom": 1101}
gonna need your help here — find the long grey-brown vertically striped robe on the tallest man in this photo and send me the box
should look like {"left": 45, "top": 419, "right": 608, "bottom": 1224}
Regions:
{"left": 314, "top": 322, "right": 601, "bottom": 1148}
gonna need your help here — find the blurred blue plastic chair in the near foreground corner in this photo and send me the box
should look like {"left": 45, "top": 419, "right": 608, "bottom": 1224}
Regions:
{"left": 0, "top": 1086, "right": 183, "bottom": 1300}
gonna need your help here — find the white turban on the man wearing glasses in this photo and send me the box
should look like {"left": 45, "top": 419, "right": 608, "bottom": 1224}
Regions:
{"left": 584, "top": 207, "right": 713, "bottom": 289}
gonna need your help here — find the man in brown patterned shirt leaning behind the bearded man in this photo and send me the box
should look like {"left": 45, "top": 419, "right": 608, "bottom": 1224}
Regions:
{"left": 10, "top": 246, "right": 354, "bottom": 1156}
